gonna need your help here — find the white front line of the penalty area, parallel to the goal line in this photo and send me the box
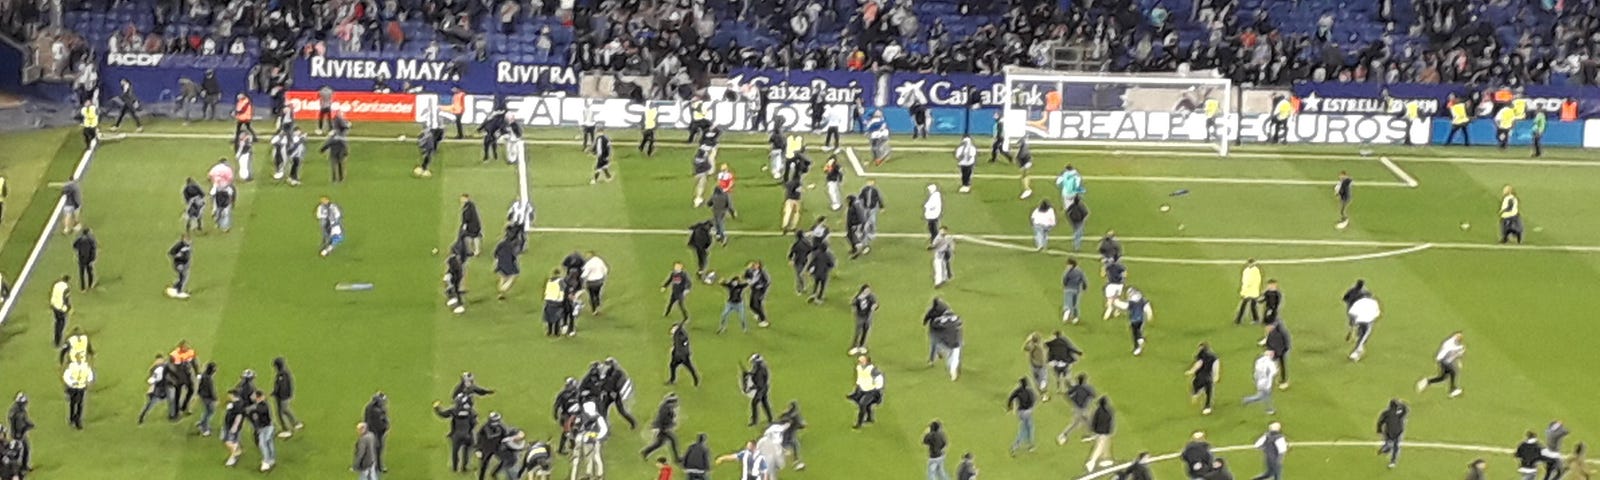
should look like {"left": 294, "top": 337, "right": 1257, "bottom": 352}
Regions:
{"left": 533, "top": 227, "right": 1600, "bottom": 254}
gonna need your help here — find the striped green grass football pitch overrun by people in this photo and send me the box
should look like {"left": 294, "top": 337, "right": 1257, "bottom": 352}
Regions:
{"left": 0, "top": 122, "right": 1600, "bottom": 480}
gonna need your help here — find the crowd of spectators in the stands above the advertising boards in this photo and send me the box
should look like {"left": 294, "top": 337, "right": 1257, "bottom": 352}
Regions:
{"left": 9, "top": 0, "right": 1600, "bottom": 96}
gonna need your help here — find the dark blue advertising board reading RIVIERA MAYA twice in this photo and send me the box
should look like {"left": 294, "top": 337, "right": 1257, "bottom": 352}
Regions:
{"left": 294, "top": 58, "right": 578, "bottom": 94}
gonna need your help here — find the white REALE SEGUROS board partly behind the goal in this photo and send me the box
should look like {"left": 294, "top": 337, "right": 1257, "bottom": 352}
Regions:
{"left": 1005, "top": 110, "right": 1430, "bottom": 144}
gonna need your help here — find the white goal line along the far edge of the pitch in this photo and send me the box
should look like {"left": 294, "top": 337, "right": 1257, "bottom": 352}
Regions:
{"left": 126, "top": 133, "right": 1600, "bottom": 166}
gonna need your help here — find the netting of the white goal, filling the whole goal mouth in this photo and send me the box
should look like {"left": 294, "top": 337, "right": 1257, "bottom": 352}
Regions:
{"left": 1000, "top": 67, "right": 1237, "bottom": 155}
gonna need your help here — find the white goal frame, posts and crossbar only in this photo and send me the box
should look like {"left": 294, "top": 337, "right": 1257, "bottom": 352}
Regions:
{"left": 1000, "top": 67, "right": 1240, "bottom": 157}
